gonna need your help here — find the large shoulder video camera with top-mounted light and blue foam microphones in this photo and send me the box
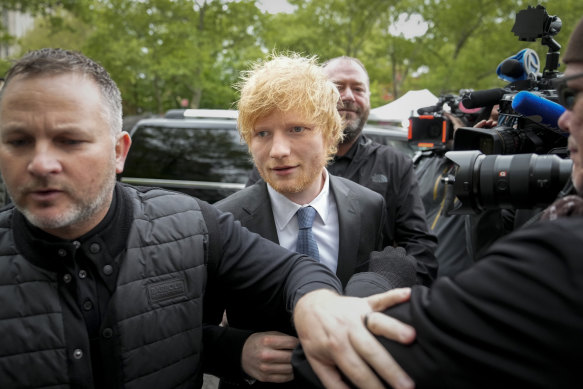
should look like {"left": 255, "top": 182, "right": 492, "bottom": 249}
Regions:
{"left": 453, "top": 5, "right": 567, "bottom": 157}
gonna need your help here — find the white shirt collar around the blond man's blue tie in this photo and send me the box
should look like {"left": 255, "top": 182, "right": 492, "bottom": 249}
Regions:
{"left": 267, "top": 169, "right": 330, "bottom": 231}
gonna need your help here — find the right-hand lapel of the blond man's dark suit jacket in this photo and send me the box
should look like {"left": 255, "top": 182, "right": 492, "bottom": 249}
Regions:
{"left": 330, "top": 175, "right": 361, "bottom": 285}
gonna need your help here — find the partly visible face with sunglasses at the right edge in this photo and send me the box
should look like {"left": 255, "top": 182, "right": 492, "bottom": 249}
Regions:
{"left": 559, "top": 63, "right": 583, "bottom": 195}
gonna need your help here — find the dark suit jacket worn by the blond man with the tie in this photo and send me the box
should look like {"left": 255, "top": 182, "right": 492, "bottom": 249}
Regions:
{"left": 215, "top": 175, "right": 386, "bottom": 286}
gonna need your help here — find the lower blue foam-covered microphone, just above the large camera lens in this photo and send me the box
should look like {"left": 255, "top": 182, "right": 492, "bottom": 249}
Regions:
{"left": 512, "top": 91, "right": 565, "bottom": 128}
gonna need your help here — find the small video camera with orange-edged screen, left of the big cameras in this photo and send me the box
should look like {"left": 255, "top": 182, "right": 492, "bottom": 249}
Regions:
{"left": 408, "top": 89, "right": 481, "bottom": 150}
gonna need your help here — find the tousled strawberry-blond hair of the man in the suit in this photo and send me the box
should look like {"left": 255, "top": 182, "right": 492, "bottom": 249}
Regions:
{"left": 236, "top": 53, "right": 343, "bottom": 159}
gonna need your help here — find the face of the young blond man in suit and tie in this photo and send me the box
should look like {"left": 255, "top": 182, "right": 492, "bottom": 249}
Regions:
{"left": 249, "top": 110, "right": 328, "bottom": 203}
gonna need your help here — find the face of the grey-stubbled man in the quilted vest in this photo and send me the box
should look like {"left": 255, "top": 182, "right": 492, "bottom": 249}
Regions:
{"left": 0, "top": 74, "right": 130, "bottom": 239}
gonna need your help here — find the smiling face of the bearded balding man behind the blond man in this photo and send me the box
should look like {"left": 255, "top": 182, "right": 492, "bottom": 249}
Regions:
{"left": 324, "top": 60, "right": 370, "bottom": 143}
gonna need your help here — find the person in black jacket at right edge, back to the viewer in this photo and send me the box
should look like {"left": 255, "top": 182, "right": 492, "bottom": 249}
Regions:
{"left": 294, "top": 13, "right": 583, "bottom": 388}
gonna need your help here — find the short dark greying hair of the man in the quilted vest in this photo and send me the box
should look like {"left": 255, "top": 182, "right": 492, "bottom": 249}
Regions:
{"left": 0, "top": 48, "right": 122, "bottom": 134}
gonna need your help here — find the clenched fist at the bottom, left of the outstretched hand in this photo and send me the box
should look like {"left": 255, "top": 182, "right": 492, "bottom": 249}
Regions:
{"left": 241, "top": 331, "right": 299, "bottom": 383}
